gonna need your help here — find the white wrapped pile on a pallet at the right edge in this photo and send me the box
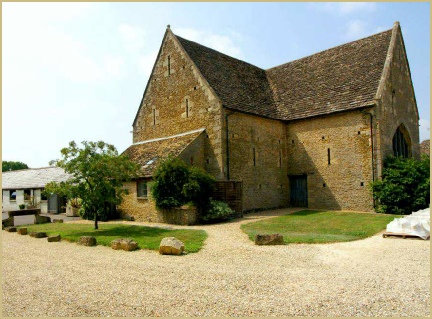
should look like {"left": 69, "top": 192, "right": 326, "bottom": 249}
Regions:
{"left": 387, "top": 208, "right": 430, "bottom": 239}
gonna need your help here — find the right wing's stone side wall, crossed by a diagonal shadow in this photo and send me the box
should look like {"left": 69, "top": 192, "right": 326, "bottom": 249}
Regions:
{"left": 287, "top": 111, "right": 373, "bottom": 211}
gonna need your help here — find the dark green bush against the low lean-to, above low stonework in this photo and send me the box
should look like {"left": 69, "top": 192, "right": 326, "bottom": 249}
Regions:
{"left": 152, "top": 158, "right": 215, "bottom": 212}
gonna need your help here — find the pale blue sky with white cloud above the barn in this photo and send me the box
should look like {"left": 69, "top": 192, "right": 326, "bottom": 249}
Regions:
{"left": 2, "top": 2, "right": 430, "bottom": 167}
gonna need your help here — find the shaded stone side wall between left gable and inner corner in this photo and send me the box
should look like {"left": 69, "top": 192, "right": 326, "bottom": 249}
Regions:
{"left": 222, "top": 110, "right": 289, "bottom": 210}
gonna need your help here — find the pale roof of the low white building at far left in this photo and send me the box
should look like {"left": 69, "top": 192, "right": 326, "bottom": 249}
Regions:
{"left": 2, "top": 167, "right": 71, "bottom": 189}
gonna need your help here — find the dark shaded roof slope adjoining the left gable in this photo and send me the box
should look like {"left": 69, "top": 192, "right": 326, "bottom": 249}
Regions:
{"left": 176, "top": 36, "right": 276, "bottom": 117}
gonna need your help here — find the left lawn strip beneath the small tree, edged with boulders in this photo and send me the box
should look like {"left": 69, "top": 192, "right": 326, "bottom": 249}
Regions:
{"left": 24, "top": 223, "right": 207, "bottom": 253}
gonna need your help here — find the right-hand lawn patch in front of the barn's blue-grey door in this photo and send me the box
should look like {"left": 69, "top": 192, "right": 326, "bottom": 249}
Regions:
{"left": 241, "top": 210, "right": 401, "bottom": 244}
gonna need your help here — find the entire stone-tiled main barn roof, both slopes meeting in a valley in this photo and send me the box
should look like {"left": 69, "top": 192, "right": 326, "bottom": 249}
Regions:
{"left": 176, "top": 26, "right": 392, "bottom": 120}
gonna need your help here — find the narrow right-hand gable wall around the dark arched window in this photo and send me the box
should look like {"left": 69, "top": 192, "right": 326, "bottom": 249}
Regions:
{"left": 374, "top": 29, "right": 420, "bottom": 176}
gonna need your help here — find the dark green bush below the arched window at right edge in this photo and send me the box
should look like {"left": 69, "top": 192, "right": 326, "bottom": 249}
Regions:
{"left": 371, "top": 156, "right": 430, "bottom": 214}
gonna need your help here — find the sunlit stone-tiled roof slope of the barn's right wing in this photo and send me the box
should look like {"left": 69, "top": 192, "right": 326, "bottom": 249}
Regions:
{"left": 267, "top": 30, "right": 392, "bottom": 120}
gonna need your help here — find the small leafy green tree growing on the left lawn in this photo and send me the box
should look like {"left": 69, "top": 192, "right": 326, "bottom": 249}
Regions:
{"left": 45, "top": 141, "right": 139, "bottom": 229}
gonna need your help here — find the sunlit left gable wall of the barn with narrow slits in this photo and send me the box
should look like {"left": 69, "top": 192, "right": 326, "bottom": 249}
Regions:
{"left": 133, "top": 30, "right": 223, "bottom": 178}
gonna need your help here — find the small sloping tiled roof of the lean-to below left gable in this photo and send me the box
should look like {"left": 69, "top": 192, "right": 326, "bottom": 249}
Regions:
{"left": 123, "top": 129, "right": 204, "bottom": 177}
